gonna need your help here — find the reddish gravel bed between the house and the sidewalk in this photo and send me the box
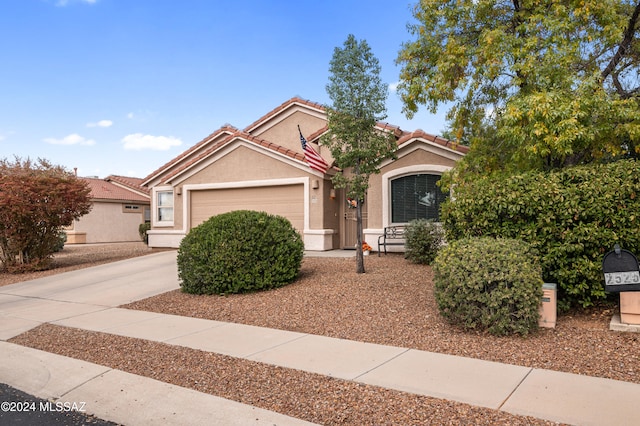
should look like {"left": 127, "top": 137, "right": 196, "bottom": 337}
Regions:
{"left": 123, "top": 255, "right": 640, "bottom": 383}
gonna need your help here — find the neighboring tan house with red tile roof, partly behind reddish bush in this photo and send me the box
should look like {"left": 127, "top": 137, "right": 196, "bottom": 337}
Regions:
{"left": 65, "top": 175, "right": 151, "bottom": 244}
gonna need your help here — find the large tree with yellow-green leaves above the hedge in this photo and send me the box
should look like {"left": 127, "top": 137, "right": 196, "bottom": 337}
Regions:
{"left": 397, "top": 0, "right": 640, "bottom": 173}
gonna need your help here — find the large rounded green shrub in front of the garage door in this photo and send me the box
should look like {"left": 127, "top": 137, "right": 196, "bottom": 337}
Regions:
{"left": 178, "top": 210, "right": 304, "bottom": 294}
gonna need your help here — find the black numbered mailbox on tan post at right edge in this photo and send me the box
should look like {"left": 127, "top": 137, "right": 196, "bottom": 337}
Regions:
{"left": 602, "top": 244, "right": 640, "bottom": 324}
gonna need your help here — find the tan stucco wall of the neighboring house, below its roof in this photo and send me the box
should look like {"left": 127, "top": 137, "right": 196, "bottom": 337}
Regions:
{"left": 71, "top": 202, "right": 144, "bottom": 243}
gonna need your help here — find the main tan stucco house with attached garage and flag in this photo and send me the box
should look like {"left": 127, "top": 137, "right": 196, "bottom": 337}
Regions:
{"left": 143, "top": 98, "right": 467, "bottom": 250}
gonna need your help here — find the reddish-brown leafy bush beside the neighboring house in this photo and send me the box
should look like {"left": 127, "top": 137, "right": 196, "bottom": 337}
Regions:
{"left": 0, "top": 157, "right": 91, "bottom": 272}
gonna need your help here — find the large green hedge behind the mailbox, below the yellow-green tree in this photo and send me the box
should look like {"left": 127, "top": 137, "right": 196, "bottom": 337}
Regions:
{"left": 441, "top": 160, "right": 640, "bottom": 309}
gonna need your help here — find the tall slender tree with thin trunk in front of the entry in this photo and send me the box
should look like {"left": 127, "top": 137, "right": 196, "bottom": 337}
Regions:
{"left": 321, "top": 34, "right": 396, "bottom": 273}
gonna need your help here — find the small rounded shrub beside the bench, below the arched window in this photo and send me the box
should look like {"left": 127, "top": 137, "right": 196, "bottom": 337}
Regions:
{"left": 404, "top": 219, "right": 444, "bottom": 265}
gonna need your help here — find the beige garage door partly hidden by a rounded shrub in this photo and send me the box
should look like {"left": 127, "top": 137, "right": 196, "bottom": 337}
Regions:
{"left": 191, "top": 185, "right": 304, "bottom": 232}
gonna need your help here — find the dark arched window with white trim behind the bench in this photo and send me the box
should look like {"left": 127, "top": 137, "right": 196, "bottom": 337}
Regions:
{"left": 391, "top": 174, "right": 448, "bottom": 223}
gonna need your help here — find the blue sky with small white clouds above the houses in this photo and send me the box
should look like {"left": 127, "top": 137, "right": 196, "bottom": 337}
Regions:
{"left": 0, "top": 0, "right": 445, "bottom": 177}
